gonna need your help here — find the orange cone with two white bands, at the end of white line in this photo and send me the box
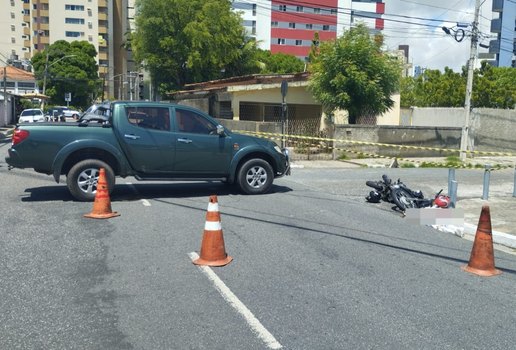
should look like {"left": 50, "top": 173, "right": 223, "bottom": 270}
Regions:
{"left": 193, "top": 195, "right": 233, "bottom": 266}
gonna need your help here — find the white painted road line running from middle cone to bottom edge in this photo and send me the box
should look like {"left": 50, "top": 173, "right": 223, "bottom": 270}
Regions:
{"left": 188, "top": 252, "right": 283, "bottom": 349}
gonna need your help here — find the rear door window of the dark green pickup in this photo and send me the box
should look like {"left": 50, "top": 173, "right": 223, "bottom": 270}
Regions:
{"left": 125, "top": 107, "right": 170, "bottom": 131}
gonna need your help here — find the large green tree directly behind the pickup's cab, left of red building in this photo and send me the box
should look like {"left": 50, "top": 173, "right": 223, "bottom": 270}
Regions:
{"left": 131, "top": 0, "right": 256, "bottom": 92}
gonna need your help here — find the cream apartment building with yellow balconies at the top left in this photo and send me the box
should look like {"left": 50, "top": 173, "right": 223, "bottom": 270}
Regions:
{"left": 0, "top": 0, "right": 135, "bottom": 99}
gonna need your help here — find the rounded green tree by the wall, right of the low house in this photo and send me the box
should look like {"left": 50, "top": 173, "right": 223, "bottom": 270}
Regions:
{"left": 309, "top": 24, "right": 401, "bottom": 124}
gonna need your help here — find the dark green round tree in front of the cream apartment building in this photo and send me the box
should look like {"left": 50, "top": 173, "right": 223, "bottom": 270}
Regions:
{"left": 32, "top": 40, "right": 102, "bottom": 108}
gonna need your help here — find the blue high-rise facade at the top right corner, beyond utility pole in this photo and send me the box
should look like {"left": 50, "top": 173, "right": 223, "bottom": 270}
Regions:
{"left": 489, "top": 0, "right": 516, "bottom": 67}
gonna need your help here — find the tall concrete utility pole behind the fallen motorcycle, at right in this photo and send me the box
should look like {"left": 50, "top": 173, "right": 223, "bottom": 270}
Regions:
{"left": 460, "top": 0, "right": 480, "bottom": 161}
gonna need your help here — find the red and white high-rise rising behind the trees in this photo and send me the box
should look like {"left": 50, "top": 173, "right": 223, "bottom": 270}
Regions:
{"left": 232, "top": 0, "right": 385, "bottom": 60}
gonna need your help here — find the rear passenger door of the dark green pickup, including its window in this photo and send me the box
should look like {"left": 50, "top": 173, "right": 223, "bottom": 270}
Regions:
{"left": 117, "top": 105, "right": 176, "bottom": 175}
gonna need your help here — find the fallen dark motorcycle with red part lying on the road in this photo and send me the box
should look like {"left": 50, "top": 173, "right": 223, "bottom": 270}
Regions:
{"left": 366, "top": 174, "right": 451, "bottom": 212}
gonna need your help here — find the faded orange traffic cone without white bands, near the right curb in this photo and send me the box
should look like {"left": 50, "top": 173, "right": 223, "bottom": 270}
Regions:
{"left": 462, "top": 205, "right": 502, "bottom": 277}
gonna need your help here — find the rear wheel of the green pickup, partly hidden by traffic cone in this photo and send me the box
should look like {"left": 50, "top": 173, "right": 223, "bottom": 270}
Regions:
{"left": 66, "top": 159, "right": 115, "bottom": 202}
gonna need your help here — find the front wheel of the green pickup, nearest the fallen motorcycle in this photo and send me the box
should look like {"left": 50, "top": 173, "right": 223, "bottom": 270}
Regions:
{"left": 237, "top": 159, "right": 274, "bottom": 194}
